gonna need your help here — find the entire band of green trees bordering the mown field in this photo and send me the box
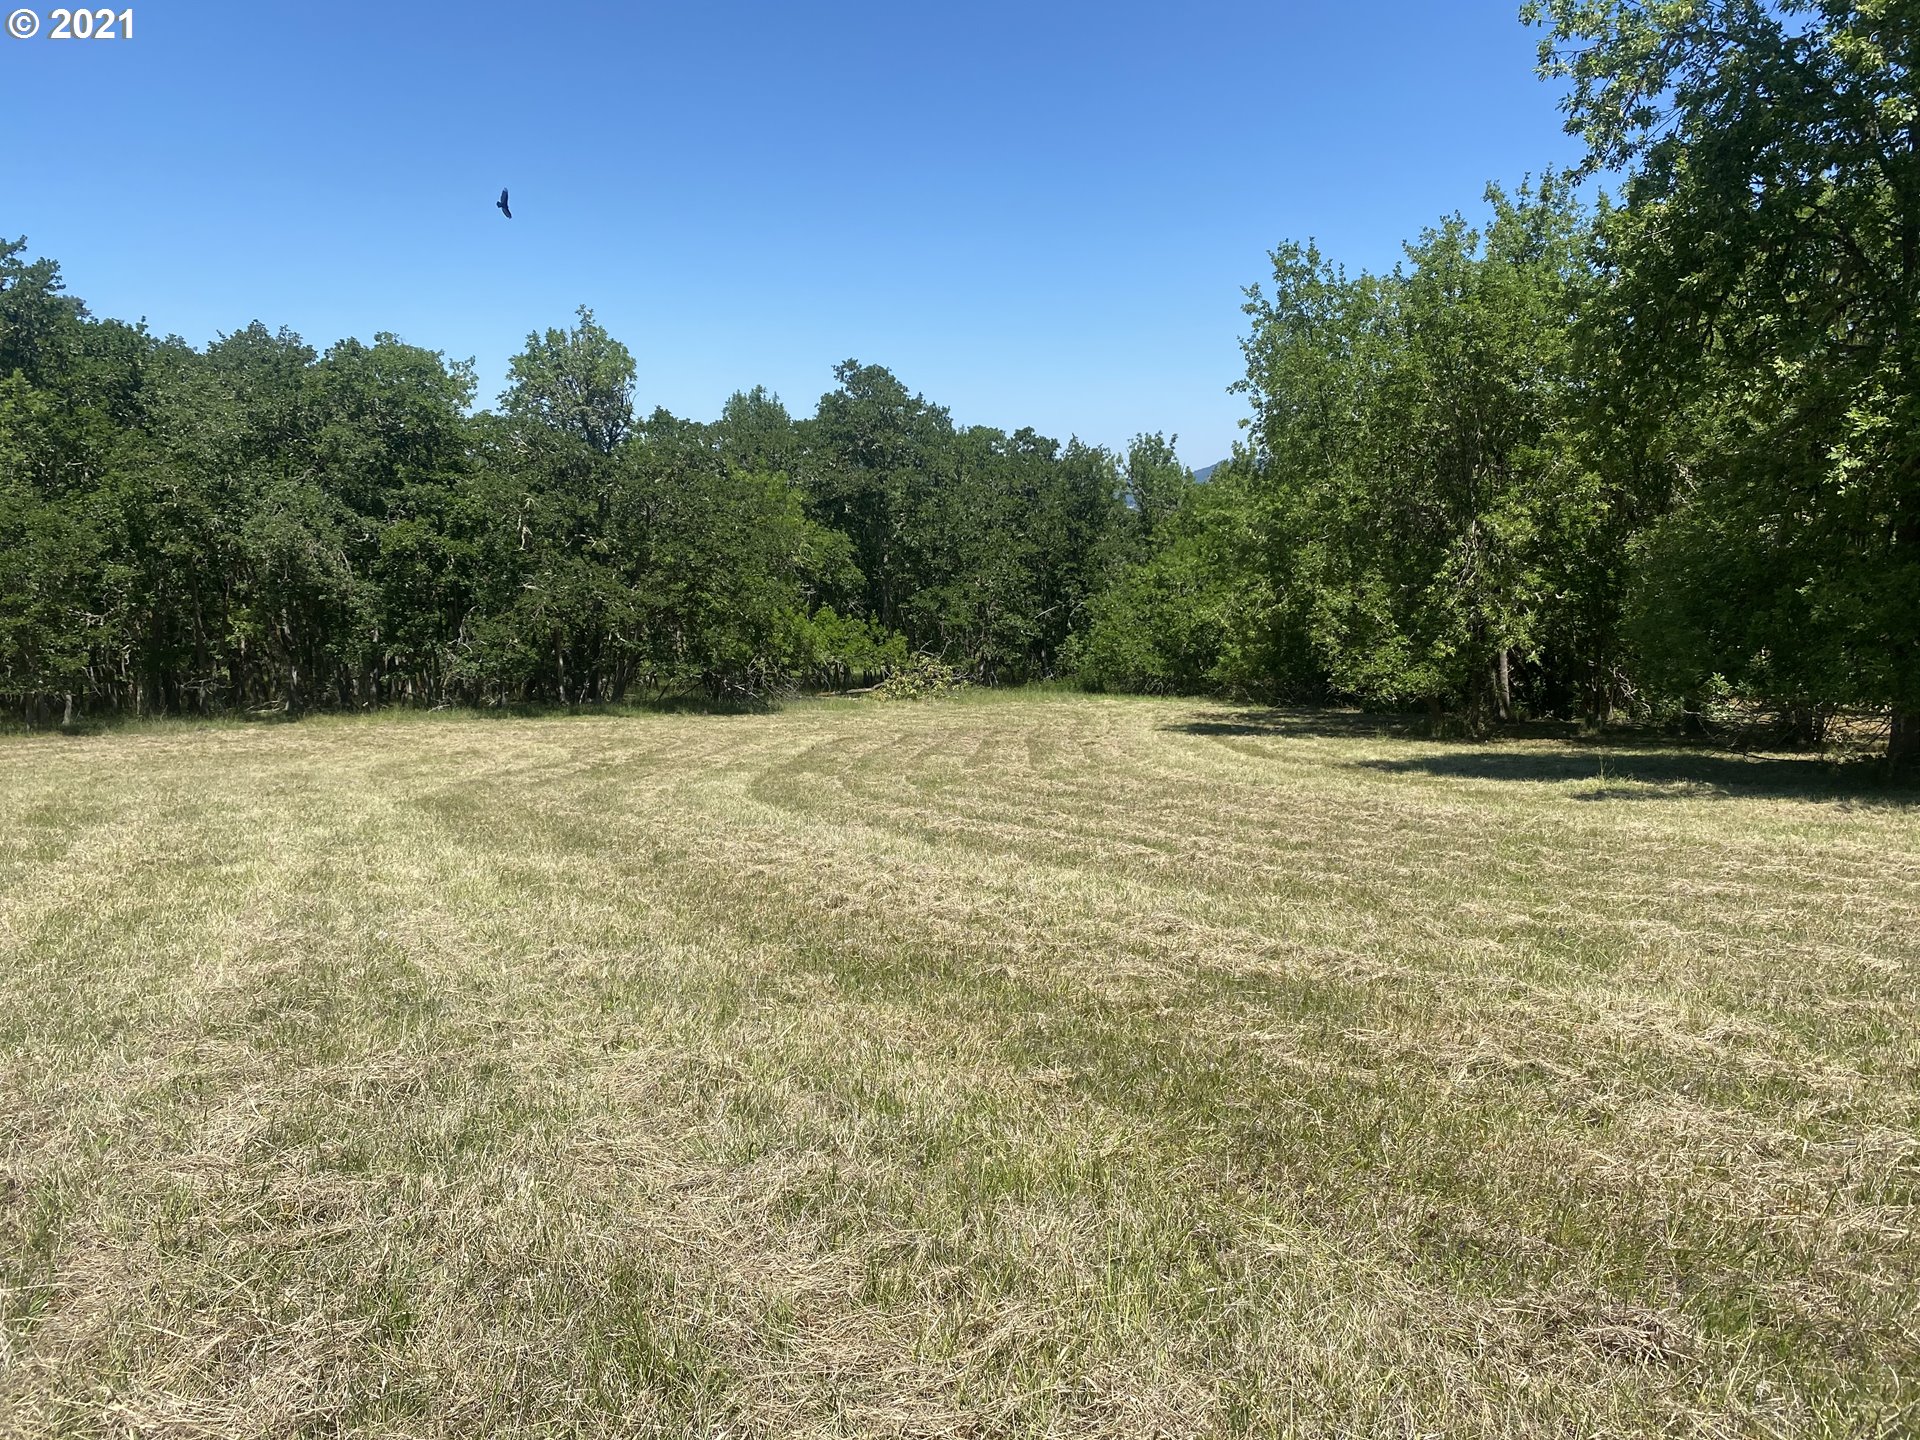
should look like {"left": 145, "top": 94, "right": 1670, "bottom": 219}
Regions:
{"left": 0, "top": 0, "right": 1920, "bottom": 758}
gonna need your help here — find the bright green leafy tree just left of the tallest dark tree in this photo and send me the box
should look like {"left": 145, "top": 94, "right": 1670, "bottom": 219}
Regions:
{"left": 1242, "top": 182, "right": 1588, "bottom": 724}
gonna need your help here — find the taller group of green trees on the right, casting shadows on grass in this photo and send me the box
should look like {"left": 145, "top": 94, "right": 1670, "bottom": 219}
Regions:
{"left": 1079, "top": 0, "right": 1920, "bottom": 760}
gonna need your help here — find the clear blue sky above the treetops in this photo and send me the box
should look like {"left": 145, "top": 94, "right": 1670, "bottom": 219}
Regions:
{"left": 0, "top": 0, "right": 1574, "bottom": 465}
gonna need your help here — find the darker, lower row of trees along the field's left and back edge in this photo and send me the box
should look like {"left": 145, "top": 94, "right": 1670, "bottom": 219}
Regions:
{"left": 0, "top": 261, "right": 1173, "bottom": 720}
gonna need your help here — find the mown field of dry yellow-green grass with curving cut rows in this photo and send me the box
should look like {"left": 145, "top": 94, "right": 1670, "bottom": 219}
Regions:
{"left": 0, "top": 695, "right": 1920, "bottom": 1440}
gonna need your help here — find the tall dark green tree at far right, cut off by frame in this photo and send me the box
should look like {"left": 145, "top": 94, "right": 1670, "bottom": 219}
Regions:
{"left": 1528, "top": 0, "right": 1920, "bottom": 758}
